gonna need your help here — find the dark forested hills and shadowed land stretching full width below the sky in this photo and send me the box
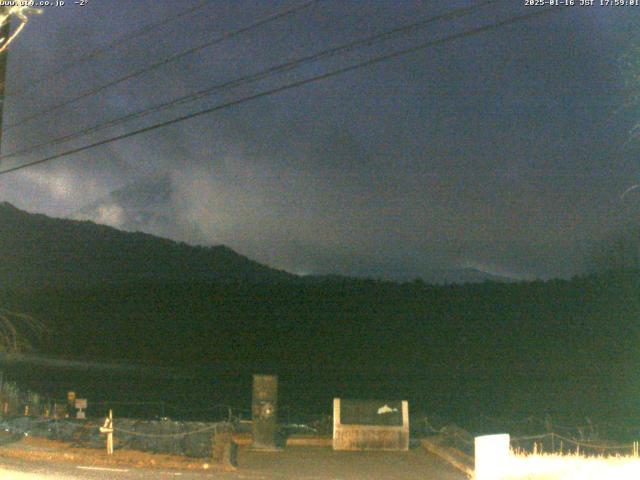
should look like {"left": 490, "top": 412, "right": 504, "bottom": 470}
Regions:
{"left": 0, "top": 204, "right": 640, "bottom": 416}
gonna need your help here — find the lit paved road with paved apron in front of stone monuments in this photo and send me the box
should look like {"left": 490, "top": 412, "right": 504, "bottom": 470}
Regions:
{"left": 0, "top": 447, "right": 466, "bottom": 480}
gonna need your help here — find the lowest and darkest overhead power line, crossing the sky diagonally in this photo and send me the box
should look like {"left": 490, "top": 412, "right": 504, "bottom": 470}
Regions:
{"left": 0, "top": 7, "right": 566, "bottom": 175}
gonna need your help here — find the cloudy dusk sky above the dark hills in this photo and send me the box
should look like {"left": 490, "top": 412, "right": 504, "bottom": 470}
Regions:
{"left": 0, "top": 0, "right": 640, "bottom": 281}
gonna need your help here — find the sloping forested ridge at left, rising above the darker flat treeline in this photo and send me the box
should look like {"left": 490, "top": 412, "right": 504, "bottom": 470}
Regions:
{"left": 0, "top": 202, "right": 296, "bottom": 287}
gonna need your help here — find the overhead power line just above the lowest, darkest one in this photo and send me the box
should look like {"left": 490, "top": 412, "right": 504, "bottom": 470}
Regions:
{"left": 0, "top": 0, "right": 505, "bottom": 161}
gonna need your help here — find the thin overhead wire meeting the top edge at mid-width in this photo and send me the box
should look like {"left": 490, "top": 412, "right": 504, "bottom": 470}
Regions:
{"left": 4, "top": 0, "right": 321, "bottom": 131}
